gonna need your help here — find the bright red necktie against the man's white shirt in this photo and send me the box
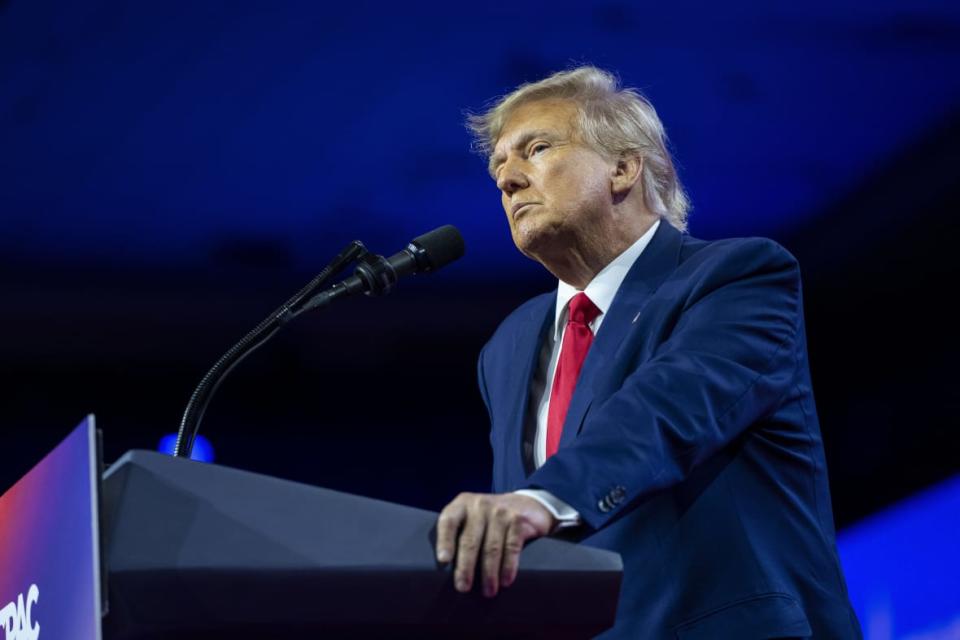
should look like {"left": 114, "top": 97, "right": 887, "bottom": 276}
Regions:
{"left": 546, "top": 291, "right": 600, "bottom": 458}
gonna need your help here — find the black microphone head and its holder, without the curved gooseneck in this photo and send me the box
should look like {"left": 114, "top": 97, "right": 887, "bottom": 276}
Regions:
{"left": 297, "top": 224, "right": 465, "bottom": 315}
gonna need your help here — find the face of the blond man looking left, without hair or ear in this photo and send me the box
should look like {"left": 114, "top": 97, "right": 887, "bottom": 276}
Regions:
{"left": 490, "top": 100, "right": 615, "bottom": 262}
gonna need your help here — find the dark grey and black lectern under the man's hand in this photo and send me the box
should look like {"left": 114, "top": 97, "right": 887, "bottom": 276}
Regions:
{"left": 102, "top": 451, "right": 622, "bottom": 640}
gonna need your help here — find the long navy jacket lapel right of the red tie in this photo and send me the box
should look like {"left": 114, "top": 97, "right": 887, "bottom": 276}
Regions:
{"left": 560, "top": 220, "right": 682, "bottom": 448}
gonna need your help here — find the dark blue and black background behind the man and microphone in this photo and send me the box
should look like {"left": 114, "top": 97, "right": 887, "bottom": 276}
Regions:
{"left": 0, "top": 0, "right": 960, "bottom": 526}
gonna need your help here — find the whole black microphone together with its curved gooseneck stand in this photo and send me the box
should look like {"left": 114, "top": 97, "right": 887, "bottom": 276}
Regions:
{"left": 173, "top": 225, "right": 464, "bottom": 458}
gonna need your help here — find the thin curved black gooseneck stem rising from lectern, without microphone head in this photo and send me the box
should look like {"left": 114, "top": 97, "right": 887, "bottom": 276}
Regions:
{"left": 173, "top": 240, "right": 367, "bottom": 458}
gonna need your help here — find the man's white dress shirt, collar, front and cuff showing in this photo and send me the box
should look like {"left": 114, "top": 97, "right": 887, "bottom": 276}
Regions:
{"left": 516, "top": 220, "right": 660, "bottom": 528}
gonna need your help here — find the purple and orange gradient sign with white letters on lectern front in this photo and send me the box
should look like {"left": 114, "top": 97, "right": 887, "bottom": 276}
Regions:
{"left": 0, "top": 416, "right": 100, "bottom": 640}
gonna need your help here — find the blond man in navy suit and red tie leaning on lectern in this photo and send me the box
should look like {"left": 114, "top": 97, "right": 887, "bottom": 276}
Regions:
{"left": 437, "top": 67, "right": 861, "bottom": 640}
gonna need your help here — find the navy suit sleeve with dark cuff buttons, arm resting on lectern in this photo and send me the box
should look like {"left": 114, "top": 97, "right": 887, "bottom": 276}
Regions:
{"left": 529, "top": 240, "right": 802, "bottom": 529}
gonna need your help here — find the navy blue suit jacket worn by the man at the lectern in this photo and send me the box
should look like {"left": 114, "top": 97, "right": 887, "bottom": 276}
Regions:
{"left": 478, "top": 221, "right": 861, "bottom": 640}
